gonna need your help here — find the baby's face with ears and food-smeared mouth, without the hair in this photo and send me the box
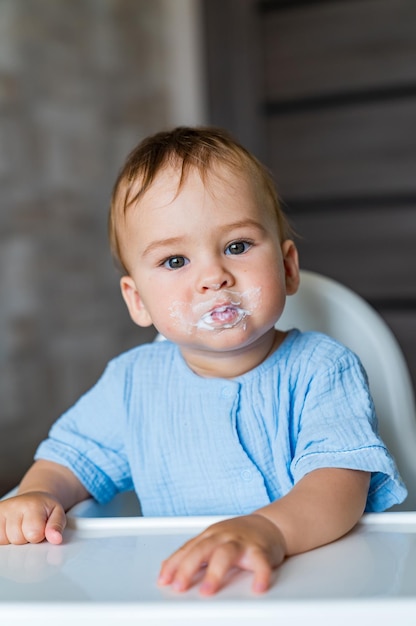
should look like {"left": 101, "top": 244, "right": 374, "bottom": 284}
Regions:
{"left": 118, "top": 163, "right": 298, "bottom": 372}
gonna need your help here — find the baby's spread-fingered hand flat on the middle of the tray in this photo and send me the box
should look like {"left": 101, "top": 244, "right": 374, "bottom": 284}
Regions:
{"left": 158, "top": 514, "right": 286, "bottom": 595}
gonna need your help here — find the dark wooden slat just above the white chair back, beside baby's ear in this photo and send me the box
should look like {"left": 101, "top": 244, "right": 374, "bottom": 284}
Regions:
{"left": 292, "top": 206, "right": 416, "bottom": 300}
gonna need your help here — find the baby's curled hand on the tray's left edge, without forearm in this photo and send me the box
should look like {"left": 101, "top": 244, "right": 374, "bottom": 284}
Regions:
{"left": 0, "top": 491, "right": 66, "bottom": 545}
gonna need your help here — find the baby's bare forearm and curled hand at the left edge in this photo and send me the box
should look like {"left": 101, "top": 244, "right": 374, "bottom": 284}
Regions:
{"left": 0, "top": 461, "right": 89, "bottom": 545}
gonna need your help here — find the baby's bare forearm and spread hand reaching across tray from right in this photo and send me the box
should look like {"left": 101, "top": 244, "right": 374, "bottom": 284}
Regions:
{"left": 159, "top": 468, "right": 370, "bottom": 595}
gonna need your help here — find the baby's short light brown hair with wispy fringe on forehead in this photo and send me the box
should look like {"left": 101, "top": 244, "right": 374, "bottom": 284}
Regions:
{"left": 109, "top": 126, "right": 292, "bottom": 272}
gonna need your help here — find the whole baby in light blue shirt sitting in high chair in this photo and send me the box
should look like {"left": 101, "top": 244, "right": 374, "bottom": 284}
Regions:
{"left": 0, "top": 123, "right": 406, "bottom": 595}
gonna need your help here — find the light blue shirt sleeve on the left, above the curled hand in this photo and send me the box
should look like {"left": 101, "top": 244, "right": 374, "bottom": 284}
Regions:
{"left": 35, "top": 361, "right": 133, "bottom": 502}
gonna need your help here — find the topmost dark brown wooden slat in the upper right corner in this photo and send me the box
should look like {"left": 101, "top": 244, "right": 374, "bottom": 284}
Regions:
{"left": 262, "top": 0, "right": 416, "bottom": 99}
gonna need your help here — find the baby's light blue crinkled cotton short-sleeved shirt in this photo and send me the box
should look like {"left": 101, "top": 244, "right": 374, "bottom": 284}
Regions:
{"left": 36, "top": 330, "right": 406, "bottom": 516}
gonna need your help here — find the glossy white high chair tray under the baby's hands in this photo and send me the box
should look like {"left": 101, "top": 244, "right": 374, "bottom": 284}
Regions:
{"left": 0, "top": 499, "right": 416, "bottom": 626}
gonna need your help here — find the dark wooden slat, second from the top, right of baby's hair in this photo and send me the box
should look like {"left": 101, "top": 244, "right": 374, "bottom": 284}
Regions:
{"left": 268, "top": 99, "right": 416, "bottom": 198}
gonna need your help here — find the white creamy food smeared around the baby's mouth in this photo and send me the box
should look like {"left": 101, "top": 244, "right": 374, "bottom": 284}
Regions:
{"left": 169, "top": 287, "right": 261, "bottom": 334}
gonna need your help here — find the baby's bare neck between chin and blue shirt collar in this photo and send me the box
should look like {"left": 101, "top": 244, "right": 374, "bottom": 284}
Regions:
{"left": 181, "top": 329, "right": 287, "bottom": 378}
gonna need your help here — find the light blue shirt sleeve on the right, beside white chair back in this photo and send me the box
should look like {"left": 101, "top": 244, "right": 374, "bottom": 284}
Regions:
{"left": 291, "top": 350, "right": 407, "bottom": 511}
